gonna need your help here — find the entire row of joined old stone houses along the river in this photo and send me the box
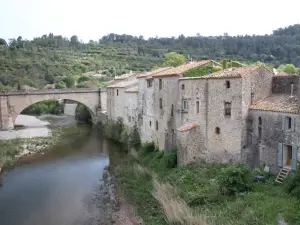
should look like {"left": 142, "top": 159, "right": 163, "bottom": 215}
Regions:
{"left": 107, "top": 60, "right": 300, "bottom": 172}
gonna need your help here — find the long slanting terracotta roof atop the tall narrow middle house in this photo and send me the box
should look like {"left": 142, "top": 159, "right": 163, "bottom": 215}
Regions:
{"left": 153, "top": 60, "right": 212, "bottom": 77}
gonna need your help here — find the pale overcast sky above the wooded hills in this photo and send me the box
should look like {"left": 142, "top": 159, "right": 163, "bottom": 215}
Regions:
{"left": 0, "top": 0, "right": 300, "bottom": 42}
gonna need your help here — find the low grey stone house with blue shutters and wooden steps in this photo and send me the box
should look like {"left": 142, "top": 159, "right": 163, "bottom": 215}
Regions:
{"left": 245, "top": 76, "right": 300, "bottom": 172}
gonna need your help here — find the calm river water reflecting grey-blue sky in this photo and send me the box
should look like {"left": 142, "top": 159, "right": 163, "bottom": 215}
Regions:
{"left": 0, "top": 116, "right": 115, "bottom": 225}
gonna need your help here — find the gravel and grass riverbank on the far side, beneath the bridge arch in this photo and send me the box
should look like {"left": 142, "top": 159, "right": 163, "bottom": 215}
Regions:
{"left": 0, "top": 116, "right": 90, "bottom": 172}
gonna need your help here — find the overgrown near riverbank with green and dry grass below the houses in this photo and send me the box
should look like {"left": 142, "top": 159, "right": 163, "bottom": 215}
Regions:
{"left": 112, "top": 145, "right": 300, "bottom": 225}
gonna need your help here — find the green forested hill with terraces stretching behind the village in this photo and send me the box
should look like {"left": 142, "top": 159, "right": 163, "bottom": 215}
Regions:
{"left": 0, "top": 24, "right": 300, "bottom": 90}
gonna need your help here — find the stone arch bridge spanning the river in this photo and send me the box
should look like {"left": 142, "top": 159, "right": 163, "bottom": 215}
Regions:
{"left": 0, "top": 88, "right": 107, "bottom": 130}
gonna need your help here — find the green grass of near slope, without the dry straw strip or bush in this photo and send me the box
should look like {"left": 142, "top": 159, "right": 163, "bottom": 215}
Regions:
{"left": 112, "top": 149, "right": 300, "bottom": 225}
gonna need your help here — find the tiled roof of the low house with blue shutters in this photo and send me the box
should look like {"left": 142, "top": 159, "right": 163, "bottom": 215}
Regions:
{"left": 250, "top": 94, "right": 300, "bottom": 114}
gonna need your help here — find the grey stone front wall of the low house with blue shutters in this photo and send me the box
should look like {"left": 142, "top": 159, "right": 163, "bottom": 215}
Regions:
{"left": 245, "top": 110, "right": 300, "bottom": 173}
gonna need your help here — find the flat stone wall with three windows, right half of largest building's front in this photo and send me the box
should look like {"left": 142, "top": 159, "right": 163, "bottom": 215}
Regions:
{"left": 207, "top": 78, "right": 242, "bottom": 163}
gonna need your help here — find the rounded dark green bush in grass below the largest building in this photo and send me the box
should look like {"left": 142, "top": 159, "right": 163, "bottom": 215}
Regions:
{"left": 216, "top": 164, "right": 251, "bottom": 195}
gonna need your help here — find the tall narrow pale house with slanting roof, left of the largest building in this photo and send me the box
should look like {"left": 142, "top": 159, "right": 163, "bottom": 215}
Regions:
{"left": 138, "top": 60, "right": 217, "bottom": 150}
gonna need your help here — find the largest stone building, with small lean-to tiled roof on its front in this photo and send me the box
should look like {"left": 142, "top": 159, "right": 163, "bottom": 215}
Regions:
{"left": 176, "top": 66, "right": 273, "bottom": 164}
